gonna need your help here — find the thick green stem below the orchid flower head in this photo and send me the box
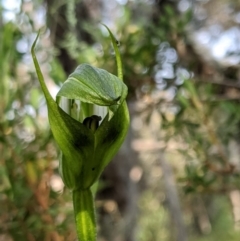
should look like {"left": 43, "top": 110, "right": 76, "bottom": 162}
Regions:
{"left": 73, "top": 188, "right": 96, "bottom": 241}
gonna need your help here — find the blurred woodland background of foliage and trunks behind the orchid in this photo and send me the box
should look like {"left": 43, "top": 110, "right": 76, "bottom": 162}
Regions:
{"left": 0, "top": 0, "right": 240, "bottom": 241}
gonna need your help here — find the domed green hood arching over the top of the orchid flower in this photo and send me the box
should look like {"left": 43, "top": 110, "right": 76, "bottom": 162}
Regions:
{"left": 57, "top": 64, "right": 127, "bottom": 106}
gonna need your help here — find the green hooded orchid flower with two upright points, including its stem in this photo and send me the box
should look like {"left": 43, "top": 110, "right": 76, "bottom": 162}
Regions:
{"left": 31, "top": 26, "right": 129, "bottom": 241}
